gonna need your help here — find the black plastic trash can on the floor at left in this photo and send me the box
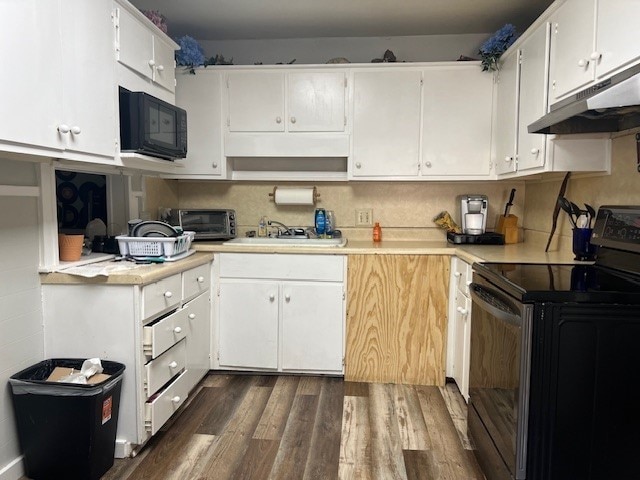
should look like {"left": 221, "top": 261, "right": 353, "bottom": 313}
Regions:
{"left": 9, "top": 358, "right": 125, "bottom": 480}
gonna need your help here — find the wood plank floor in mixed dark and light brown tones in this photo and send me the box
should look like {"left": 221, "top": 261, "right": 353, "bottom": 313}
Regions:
{"left": 103, "top": 374, "right": 484, "bottom": 480}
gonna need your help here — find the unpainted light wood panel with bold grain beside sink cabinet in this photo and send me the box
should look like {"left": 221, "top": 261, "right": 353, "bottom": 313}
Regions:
{"left": 345, "top": 255, "right": 449, "bottom": 386}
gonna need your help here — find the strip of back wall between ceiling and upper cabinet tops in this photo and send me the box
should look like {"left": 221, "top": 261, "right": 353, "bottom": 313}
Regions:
{"left": 200, "top": 33, "right": 484, "bottom": 65}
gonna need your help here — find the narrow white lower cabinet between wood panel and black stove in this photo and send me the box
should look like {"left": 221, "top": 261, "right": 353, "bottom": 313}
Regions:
{"left": 447, "top": 257, "right": 473, "bottom": 401}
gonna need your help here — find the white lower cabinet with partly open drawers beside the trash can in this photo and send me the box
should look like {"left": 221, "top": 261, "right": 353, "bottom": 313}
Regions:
{"left": 42, "top": 260, "right": 212, "bottom": 457}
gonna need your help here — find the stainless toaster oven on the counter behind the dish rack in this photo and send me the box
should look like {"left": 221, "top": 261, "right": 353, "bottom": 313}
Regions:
{"left": 172, "top": 209, "right": 236, "bottom": 240}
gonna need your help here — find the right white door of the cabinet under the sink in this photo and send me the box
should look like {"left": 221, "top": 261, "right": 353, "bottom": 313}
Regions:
{"left": 282, "top": 282, "right": 344, "bottom": 372}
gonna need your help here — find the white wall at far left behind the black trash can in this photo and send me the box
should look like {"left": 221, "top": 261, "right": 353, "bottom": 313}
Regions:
{"left": 0, "top": 158, "right": 44, "bottom": 480}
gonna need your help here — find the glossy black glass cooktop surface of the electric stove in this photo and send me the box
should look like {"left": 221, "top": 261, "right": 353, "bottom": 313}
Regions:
{"left": 473, "top": 263, "right": 640, "bottom": 304}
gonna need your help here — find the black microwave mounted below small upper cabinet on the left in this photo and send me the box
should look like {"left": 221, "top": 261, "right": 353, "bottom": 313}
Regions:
{"left": 120, "top": 87, "right": 187, "bottom": 160}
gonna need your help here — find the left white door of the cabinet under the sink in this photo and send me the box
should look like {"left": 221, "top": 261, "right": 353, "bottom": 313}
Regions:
{"left": 218, "top": 281, "right": 278, "bottom": 370}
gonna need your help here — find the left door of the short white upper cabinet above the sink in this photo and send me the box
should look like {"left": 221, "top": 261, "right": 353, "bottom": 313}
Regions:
{"left": 227, "top": 72, "right": 284, "bottom": 132}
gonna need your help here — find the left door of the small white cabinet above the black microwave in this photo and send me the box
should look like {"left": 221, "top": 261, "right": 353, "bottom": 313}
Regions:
{"left": 118, "top": 7, "right": 154, "bottom": 79}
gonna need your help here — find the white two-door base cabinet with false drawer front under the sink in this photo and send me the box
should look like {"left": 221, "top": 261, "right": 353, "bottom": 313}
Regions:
{"left": 214, "top": 253, "right": 346, "bottom": 374}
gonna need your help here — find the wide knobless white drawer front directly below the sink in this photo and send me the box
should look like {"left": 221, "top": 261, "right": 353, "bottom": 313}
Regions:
{"left": 220, "top": 253, "right": 345, "bottom": 282}
